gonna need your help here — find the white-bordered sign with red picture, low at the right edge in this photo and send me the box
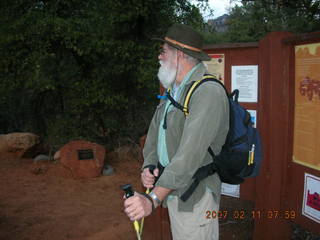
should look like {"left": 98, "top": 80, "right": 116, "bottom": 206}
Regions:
{"left": 302, "top": 173, "right": 320, "bottom": 223}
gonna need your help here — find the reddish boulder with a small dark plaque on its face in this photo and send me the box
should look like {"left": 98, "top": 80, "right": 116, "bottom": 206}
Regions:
{"left": 60, "top": 140, "right": 106, "bottom": 178}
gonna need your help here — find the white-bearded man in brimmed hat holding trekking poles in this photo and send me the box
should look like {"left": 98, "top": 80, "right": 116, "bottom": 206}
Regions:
{"left": 124, "top": 24, "right": 229, "bottom": 240}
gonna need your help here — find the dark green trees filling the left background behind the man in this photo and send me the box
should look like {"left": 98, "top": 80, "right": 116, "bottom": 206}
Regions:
{"left": 0, "top": 0, "right": 203, "bottom": 149}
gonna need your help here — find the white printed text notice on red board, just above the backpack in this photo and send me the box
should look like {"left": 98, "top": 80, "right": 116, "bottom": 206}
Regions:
{"left": 231, "top": 65, "right": 258, "bottom": 102}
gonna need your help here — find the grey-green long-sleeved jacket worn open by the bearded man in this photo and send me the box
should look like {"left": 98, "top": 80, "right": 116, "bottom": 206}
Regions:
{"left": 143, "top": 64, "right": 229, "bottom": 211}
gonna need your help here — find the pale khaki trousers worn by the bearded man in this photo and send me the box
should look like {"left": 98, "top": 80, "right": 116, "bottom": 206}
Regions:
{"left": 167, "top": 191, "right": 219, "bottom": 240}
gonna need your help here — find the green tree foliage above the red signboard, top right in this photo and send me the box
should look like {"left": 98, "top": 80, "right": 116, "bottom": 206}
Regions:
{"left": 226, "top": 0, "right": 320, "bottom": 42}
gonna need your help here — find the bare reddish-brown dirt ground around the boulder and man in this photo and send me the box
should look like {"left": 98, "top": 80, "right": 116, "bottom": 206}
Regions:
{"left": 0, "top": 149, "right": 253, "bottom": 240}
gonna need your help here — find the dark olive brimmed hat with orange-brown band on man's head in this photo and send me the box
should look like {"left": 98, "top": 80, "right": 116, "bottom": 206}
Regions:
{"left": 153, "top": 23, "right": 211, "bottom": 61}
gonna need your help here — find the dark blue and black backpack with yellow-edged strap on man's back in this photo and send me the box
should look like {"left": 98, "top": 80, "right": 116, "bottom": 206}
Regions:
{"left": 167, "top": 74, "right": 262, "bottom": 201}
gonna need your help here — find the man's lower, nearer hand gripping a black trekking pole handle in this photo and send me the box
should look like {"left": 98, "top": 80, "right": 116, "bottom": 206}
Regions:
{"left": 124, "top": 192, "right": 152, "bottom": 221}
